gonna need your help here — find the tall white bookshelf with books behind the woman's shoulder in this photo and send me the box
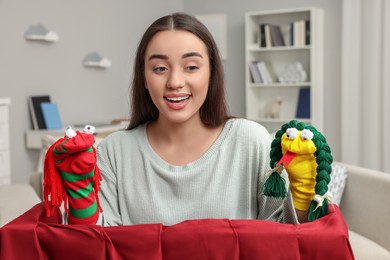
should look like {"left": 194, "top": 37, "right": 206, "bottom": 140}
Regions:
{"left": 245, "top": 7, "right": 324, "bottom": 132}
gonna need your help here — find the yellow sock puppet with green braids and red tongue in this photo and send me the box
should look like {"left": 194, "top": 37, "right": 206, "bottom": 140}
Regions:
{"left": 264, "top": 120, "right": 333, "bottom": 221}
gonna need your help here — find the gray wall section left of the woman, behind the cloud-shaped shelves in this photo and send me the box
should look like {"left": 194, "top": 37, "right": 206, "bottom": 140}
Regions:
{"left": 0, "top": 0, "right": 183, "bottom": 182}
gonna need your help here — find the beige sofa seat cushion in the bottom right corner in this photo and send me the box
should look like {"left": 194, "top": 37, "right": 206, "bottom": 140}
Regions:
{"left": 349, "top": 230, "right": 390, "bottom": 259}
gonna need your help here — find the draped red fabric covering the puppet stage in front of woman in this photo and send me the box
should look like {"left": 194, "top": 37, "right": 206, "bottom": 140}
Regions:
{"left": 0, "top": 203, "right": 354, "bottom": 260}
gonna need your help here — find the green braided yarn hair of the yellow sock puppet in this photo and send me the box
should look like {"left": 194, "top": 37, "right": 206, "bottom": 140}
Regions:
{"left": 264, "top": 120, "right": 333, "bottom": 221}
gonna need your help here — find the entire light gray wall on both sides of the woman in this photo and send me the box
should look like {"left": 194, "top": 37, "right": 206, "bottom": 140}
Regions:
{"left": 0, "top": 0, "right": 342, "bottom": 182}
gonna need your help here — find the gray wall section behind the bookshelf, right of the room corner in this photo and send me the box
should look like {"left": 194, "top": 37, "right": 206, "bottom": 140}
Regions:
{"left": 184, "top": 0, "right": 343, "bottom": 159}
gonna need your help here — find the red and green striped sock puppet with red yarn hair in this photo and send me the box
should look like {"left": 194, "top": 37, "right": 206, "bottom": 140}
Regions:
{"left": 43, "top": 125, "right": 102, "bottom": 224}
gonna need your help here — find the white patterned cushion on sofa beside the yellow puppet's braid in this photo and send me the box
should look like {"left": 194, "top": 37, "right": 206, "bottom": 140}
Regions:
{"left": 328, "top": 163, "right": 348, "bottom": 205}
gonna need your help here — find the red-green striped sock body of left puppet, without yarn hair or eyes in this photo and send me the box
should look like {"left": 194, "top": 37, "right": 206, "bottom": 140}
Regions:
{"left": 45, "top": 132, "right": 101, "bottom": 224}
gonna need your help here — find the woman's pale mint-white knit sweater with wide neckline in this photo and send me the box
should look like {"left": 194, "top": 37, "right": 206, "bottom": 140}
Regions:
{"left": 97, "top": 119, "right": 298, "bottom": 226}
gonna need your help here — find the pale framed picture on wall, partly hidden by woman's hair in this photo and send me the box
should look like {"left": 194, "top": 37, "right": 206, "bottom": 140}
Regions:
{"left": 195, "top": 14, "right": 227, "bottom": 60}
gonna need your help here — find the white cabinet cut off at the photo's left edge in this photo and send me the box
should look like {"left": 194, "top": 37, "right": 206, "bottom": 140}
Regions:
{"left": 0, "top": 97, "right": 11, "bottom": 185}
